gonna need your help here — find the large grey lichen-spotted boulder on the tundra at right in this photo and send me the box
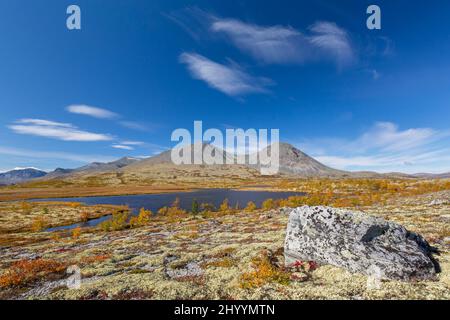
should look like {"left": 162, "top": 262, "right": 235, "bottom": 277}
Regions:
{"left": 285, "top": 206, "right": 440, "bottom": 280}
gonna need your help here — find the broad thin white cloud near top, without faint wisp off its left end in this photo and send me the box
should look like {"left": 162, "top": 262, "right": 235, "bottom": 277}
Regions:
{"left": 209, "top": 16, "right": 355, "bottom": 67}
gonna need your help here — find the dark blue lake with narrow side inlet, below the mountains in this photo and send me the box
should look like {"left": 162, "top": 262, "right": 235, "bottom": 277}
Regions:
{"left": 35, "top": 189, "right": 304, "bottom": 232}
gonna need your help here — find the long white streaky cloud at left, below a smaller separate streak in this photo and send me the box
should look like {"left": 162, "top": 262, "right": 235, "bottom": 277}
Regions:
{"left": 8, "top": 119, "right": 112, "bottom": 141}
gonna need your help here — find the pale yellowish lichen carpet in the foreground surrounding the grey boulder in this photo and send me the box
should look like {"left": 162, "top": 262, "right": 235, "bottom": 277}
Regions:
{"left": 0, "top": 192, "right": 450, "bottom": 299}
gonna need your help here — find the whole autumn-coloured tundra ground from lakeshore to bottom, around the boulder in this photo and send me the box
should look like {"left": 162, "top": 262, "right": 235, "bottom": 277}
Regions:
{"left": 0, "top": 180, "right": 450, "bottom": 299}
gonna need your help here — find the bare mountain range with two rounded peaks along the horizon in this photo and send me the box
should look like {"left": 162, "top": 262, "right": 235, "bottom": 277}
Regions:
{"left": 0, "top": 143, "right": 450, "bottom": 185}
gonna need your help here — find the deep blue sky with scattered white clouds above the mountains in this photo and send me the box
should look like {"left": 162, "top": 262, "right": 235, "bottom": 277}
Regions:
{"left": 0, "top": 0, "right": 450, "bottom": 172}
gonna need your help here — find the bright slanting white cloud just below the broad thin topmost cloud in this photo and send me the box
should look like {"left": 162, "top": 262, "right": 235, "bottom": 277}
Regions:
{"left": 180, "top": 53, "right": 272, "bottom": 96}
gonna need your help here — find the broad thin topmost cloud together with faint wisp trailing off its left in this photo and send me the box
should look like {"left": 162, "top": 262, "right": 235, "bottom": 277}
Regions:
{"left": 171, "top": 8, "right": 356, "bottom": 67}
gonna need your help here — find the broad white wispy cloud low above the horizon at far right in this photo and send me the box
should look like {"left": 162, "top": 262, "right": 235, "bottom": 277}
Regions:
{"left": 298, "top": 122, "right": 450, "bottom": 173}
